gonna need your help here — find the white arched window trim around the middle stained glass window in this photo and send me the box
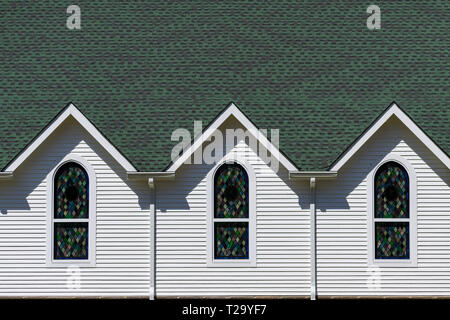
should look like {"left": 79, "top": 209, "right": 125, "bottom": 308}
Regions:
{"left": 206, "top": 154, "right": 256, "bottom": 267}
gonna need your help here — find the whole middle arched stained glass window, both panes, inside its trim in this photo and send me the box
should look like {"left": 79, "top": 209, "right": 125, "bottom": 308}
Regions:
{"left": 213, "top": 163, "right": 250, "bottom": 259}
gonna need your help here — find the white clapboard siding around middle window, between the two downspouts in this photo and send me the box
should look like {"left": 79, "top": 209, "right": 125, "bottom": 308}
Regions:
{"left": 156, "top": 120, "right": 311, "bottom": 297}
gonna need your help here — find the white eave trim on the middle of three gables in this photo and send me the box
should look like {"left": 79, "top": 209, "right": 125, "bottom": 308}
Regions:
{"left": 167, "top": 103, "right": 297, "bottom": 171}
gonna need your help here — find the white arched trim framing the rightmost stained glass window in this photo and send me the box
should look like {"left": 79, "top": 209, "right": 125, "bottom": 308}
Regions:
{"left": 367, "top": 153, "right": 417, "bottom": 267}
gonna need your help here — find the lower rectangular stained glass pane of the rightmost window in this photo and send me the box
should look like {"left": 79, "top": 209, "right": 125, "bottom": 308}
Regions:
{"left": 375, "top": 222, "right": 409, "bottom": 259}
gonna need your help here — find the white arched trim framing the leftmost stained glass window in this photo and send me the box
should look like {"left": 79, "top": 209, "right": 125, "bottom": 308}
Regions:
{"left": 46, "top": 154, "right": 97, "bottom": 267}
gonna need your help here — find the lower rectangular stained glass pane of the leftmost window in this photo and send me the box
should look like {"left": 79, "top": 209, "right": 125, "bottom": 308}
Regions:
{"left": 55, "top": 223, "right": 88, "bottom": 259}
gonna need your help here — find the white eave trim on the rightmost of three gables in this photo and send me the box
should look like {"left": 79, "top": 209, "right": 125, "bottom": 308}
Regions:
{"left": 330, "top": 103, "right": 450, "bottom": 171}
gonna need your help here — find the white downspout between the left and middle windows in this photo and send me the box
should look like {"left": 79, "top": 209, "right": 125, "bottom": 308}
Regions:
{"left": 148, "top": 178, "right": 156, "bottom": 300}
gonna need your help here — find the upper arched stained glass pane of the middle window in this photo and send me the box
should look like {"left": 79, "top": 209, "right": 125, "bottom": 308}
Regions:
{"left": 214, "top": 164, "right": 249, "bottom": 218}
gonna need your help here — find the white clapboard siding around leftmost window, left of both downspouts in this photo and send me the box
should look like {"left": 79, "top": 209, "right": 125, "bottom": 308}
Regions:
{"left": 0, "top": 120, "right": 150, "bottom": 297}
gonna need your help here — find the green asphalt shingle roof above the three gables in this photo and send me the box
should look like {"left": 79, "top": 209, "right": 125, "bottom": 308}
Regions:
{"left": 0, "top": 0, "right": 450, "bottom": 171}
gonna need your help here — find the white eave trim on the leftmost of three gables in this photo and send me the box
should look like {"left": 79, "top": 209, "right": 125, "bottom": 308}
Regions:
{"left": 4, "top": 103, "right": 136, "bottom": 172}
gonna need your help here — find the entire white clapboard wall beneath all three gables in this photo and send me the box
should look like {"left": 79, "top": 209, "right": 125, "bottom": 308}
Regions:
{"left": 0, "top": 110, "right": 450, "bottom": 297}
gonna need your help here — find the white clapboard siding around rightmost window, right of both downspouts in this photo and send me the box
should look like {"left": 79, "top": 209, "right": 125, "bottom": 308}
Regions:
{"left": 317, "top": 120, "right": 450, "bottom": 297}
